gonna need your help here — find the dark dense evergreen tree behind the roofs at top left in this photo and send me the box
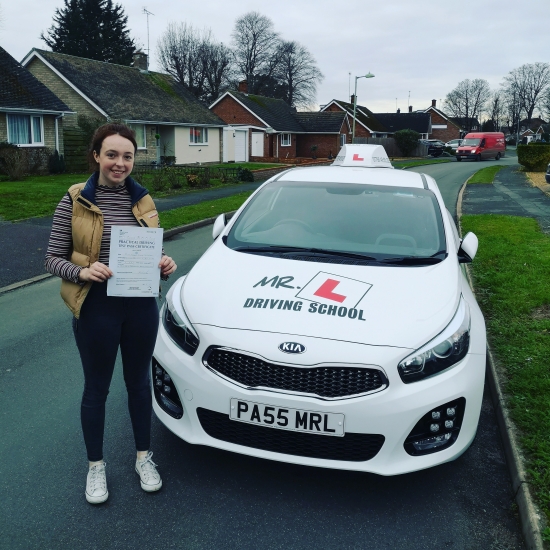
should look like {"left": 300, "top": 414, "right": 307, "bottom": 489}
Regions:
{"left": 40, "top": 0, "right": 136, "bottom": 65}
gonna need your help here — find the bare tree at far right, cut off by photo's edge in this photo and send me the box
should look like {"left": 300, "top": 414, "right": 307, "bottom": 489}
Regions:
{"left": 503, "top": 63, "right": 550, "bottom": 126}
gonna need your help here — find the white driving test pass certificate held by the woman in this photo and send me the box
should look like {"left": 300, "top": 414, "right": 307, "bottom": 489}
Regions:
{"left": 107, "top": 225, "right": 162, "bottom": 297}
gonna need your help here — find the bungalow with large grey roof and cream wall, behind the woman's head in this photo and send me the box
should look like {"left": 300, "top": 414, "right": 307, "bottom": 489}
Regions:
{"left": 22, "top": 48, "right": 225, "bottom": 164}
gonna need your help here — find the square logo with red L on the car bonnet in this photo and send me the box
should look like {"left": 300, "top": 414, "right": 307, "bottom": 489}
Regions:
{"left": 296, "top": 271, "right": 372, "bottom": 308}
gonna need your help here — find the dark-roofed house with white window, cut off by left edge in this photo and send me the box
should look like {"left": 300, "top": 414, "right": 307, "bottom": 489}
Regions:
{"left": 0, "top": 48, "right": 71, "bottom": 155}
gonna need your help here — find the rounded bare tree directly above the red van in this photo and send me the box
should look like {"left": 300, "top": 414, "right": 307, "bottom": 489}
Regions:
{"left": 445, "top": 78, "right": 491, "bottom": 131}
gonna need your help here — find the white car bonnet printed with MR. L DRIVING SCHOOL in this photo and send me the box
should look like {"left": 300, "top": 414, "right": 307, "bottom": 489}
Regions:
{"left": 181, "top": 245, "right": 460, "bottom": 348}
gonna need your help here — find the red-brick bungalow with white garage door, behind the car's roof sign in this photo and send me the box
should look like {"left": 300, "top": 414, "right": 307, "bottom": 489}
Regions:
{"left": 210, "top": 81, "right": 351, "bottom": 162}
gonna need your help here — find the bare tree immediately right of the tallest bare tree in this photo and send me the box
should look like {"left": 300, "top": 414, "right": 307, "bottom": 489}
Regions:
{"left": 277, "top": 41, "right": 324, "bottom": 107}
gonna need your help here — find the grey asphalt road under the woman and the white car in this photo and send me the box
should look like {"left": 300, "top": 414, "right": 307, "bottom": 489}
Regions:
{"left": 0, "top": 156, "right": 523, "bottom": 550}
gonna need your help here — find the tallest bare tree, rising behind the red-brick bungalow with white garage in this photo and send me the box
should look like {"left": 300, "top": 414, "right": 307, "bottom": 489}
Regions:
{"left": 231, "top": 11, "right": 281, "bottom": 93}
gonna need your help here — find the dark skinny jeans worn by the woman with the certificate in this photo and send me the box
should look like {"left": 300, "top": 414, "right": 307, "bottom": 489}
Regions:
{"left": 73, "top": 283, "right": 159, "bottom": 462}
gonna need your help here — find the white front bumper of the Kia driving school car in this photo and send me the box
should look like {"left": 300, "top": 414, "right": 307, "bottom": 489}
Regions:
{"left": 153, "top": 319, "right": 485, "bottom": 475}
